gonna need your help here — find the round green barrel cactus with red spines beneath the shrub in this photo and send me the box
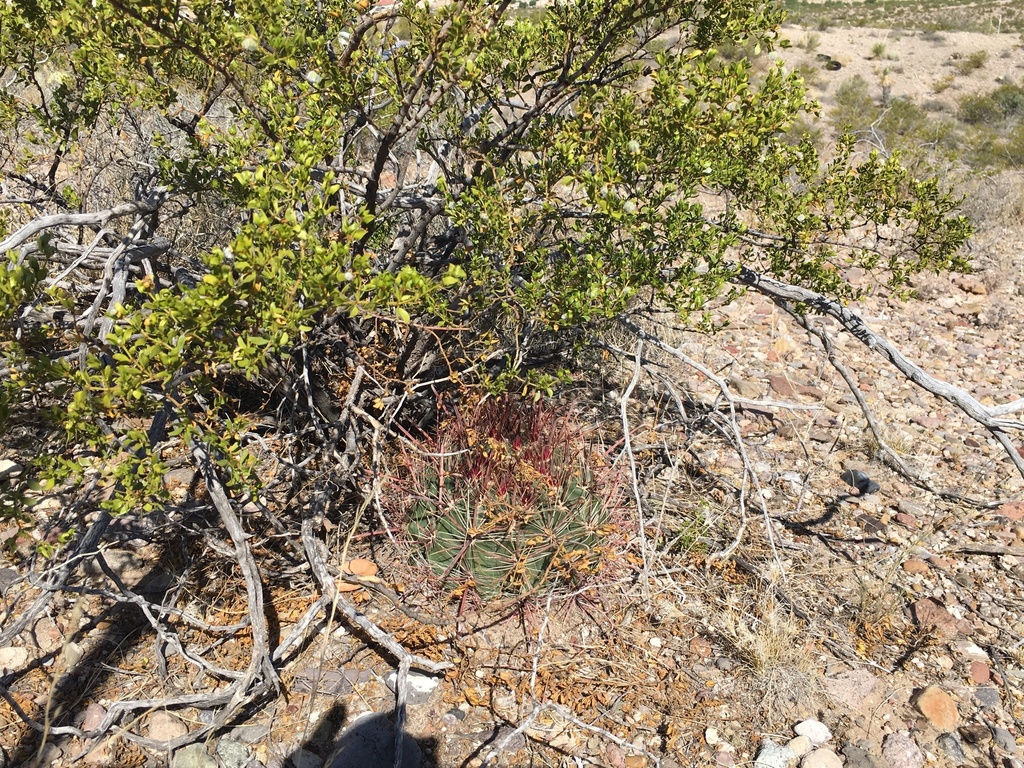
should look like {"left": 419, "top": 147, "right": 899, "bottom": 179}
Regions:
{"left": 387, "top": 396, "right": 621, "bottom": 598}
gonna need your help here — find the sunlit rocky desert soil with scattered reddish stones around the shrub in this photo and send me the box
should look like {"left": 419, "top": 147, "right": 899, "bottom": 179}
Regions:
{"left": 0, "top": 19, "right": 1024, "bottom": 768}
